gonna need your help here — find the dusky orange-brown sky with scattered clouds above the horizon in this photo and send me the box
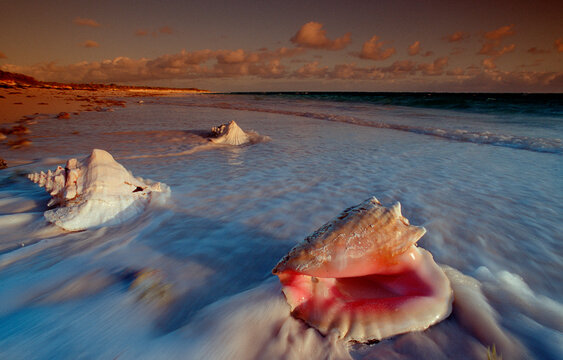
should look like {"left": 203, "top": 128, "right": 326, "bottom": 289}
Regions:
{"left": 0, "top": 0, "right": 563, "bottom": 93}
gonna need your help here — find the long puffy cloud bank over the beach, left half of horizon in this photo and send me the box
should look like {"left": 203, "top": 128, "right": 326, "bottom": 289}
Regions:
{"left": 2, "top": 48, "right": 305, "bottom": 83}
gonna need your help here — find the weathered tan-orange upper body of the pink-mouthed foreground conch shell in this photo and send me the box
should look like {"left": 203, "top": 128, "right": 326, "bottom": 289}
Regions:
{"left": 273, "top": 197, "right": 426, "bottom": 277}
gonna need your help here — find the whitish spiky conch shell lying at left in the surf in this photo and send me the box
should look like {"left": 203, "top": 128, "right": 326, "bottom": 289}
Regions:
{"left": 28, "top": 149, "right": 170, "bottom": 231}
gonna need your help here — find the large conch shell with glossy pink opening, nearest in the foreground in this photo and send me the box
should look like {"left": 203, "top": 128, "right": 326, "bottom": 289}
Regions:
{"left": 273, "top": 197, "right": 452, "bottom": 342}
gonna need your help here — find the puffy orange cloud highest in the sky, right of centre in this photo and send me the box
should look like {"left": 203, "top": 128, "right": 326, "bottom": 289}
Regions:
{"left": 290, "top": 21, "right": 351, "bottom": 50}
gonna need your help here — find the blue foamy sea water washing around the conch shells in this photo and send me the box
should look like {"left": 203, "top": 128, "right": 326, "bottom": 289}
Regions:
{"left": 0, "top": 93, "right": 563, "bottom": 359}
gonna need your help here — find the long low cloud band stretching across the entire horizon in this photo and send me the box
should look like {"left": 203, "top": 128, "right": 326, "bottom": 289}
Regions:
{"left": 0, "top": 41, "right": 563, "bottom": 92}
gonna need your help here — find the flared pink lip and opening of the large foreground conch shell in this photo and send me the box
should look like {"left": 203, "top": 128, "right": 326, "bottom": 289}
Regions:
{"left": 278, "top": 248, "right": 453, "bottom": 342}
